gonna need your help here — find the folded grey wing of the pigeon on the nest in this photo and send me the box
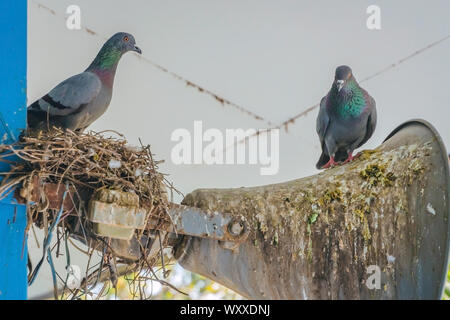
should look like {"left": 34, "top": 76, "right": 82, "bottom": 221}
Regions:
{"left": 29, "top": 72, "right": 102, "bottom": 116}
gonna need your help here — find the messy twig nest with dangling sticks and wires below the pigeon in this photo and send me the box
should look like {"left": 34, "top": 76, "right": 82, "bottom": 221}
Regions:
{"left": 0, "top": 129, "right": 176, "bottom": 299}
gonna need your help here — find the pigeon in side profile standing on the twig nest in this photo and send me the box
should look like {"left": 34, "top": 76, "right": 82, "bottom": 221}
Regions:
{"left": 27, "top": 32, "right": 142, "bottom": 132}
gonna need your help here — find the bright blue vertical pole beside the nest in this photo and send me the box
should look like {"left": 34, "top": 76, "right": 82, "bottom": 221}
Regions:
{"left": 0, "top": 0, "right": 27, "bottom": 300}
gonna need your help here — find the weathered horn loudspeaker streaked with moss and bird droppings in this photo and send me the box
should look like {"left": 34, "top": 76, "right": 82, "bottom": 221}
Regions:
{"left": 176, "top": 122, "right": 449, "bottom": 299}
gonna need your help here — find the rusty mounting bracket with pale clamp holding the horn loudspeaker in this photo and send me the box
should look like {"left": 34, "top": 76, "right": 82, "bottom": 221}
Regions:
{"left": 16, "top": 185, "right": 249, "bottom": 260}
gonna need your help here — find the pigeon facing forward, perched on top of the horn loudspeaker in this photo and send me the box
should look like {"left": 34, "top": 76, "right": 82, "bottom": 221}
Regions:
{"left": 316, "top": 66, "right": 377, "bottom": 169}
